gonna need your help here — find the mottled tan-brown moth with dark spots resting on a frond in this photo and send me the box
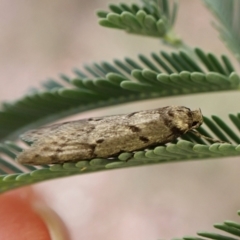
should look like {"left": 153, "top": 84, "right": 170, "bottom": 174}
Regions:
{"left": 17, "top": 106, "right": 221, "bottom": 165}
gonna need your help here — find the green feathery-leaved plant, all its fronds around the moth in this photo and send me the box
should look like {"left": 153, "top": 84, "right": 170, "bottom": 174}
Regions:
{"left": 0, "top": 0, "right": 240, "bottom": 239}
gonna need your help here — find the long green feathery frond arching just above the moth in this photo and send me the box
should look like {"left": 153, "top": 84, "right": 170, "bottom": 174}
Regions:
{"left": 0, "top": 49, "right": 240, "bottom": 141}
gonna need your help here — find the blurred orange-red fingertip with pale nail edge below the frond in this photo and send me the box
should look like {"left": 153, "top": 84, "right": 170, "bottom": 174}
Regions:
{"left": 0, "top": 187, "right": 69, "bottom": 240}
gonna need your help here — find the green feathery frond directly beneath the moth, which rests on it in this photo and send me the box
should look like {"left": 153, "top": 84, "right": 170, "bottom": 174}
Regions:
{"left": 0, "top": 110, "right": 240, "bottom": 192}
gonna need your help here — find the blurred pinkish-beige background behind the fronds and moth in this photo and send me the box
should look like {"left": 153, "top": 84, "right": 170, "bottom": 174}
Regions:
{"left": 0, "top": 0, "right": 240, "bottom": 240}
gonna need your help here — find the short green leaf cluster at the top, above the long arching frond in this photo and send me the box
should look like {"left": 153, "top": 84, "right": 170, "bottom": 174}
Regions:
{"left": 97, "top": 0, "right": 181, "bottom": 46}
